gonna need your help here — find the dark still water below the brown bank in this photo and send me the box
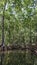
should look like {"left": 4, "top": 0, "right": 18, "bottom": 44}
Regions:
{"left": 0, "top": 51, "right": 37, "bottom": 65}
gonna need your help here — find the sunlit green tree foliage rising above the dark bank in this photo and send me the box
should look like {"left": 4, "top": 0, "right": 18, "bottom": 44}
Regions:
{"left": 0, "top": 0, "right": 37, "bottom": 44}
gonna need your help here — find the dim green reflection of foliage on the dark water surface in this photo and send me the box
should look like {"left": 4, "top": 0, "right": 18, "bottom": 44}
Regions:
{"left": 3, "top": 51, "right": 36, "bottom": 65}
